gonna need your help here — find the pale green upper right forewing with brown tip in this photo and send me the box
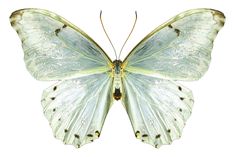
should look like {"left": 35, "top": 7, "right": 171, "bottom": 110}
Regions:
{"left": 124, "top": 9, "right": 225, "bottom": 80}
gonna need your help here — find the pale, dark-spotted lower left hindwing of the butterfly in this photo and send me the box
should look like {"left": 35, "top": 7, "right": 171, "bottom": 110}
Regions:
{"left": 42, "top": 73, "right": 113, "bottom": 147}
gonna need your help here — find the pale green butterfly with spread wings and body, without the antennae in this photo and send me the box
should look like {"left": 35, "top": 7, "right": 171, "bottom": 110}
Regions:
{"left": 10, "top": 9, "right": 225, "bottom": 148}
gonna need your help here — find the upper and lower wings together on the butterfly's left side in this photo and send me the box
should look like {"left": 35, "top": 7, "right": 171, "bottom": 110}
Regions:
{"left": 10, "top": 9, "right": 113, "bottom": 147}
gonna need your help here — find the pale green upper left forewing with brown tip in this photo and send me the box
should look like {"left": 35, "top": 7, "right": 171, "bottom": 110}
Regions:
{"left": 10, "top": 9, "right": 111, "bottom": 80}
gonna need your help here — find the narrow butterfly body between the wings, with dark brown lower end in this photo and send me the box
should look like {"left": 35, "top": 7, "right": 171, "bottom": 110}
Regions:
{"left": 112, "top": 60, "right": 122, "bottom": 100}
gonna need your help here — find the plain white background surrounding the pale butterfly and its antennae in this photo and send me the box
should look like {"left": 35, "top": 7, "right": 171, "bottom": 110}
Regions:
{"left": 0, "top": 0, "right": 236, "bottom": 157}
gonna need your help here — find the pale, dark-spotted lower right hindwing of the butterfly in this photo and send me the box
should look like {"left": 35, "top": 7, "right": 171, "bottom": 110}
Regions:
{"left": 122, "top": 72, "right": 193, "bottom": 147}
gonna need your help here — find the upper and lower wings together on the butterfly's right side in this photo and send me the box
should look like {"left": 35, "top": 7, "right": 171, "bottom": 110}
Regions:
{"left": 122, "top": 9, "right": 224, "bottom": 147}
